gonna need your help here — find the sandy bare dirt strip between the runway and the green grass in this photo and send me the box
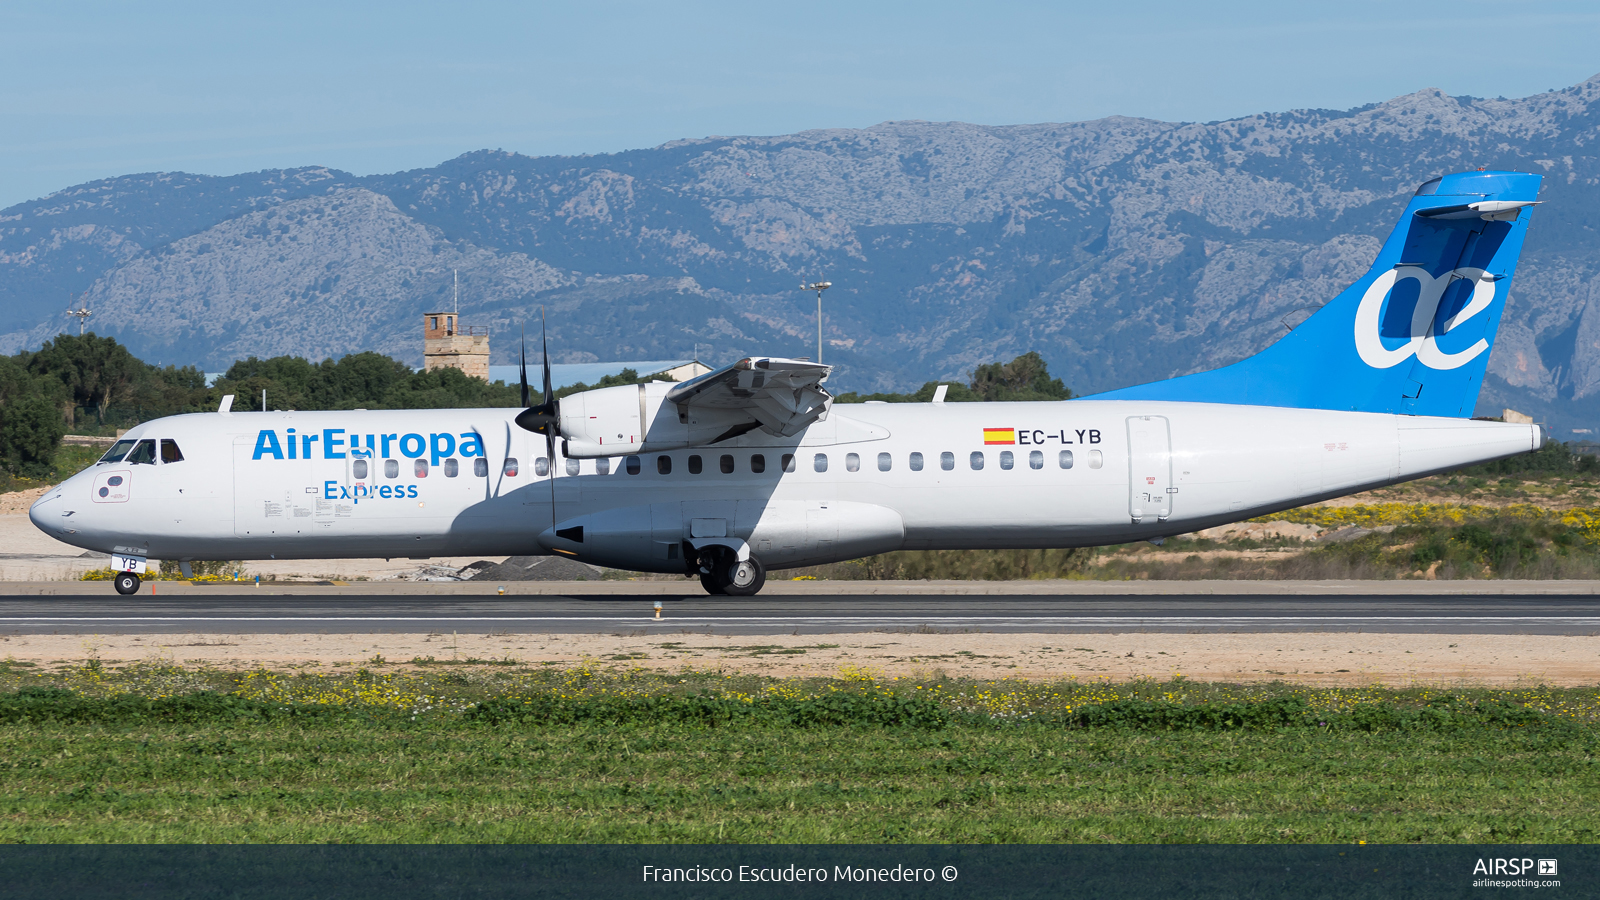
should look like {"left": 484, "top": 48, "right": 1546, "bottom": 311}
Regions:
{"left": 0, "top": 633, "right": 1600, "bottom": 687}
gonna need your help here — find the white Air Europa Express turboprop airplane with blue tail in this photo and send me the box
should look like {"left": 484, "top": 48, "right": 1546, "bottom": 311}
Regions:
{"left": 29, "top": 170, "right": 1546, "bottom": 596}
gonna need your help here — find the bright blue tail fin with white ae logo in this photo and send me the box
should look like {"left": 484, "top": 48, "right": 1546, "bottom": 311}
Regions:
{"left": 1094, "top": 171, "right": 1541, "bottom": 416}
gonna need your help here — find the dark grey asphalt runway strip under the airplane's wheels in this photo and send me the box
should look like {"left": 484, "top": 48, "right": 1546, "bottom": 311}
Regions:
{"left": 0, "top": 593, "right": 1600, "bottom": 634}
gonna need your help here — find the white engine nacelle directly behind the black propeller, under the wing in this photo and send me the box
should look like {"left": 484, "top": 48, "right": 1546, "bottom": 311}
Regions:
{"left": 560, "top": 383, "right": 755, "bottom": 460}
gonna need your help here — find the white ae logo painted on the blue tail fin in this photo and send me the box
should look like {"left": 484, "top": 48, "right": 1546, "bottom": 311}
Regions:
{"left": 1355, "top": 266, "right": 1494, "bottom": 370}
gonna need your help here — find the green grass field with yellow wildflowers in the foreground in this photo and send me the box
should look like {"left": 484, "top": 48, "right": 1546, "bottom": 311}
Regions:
{"left": 0, "top": 663, "right": 1600, "bottom": 842}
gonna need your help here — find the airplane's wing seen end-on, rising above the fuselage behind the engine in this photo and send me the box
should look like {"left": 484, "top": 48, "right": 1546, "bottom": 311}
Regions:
{"left": 666, "top": 357, "right": 834, "bottom": 437}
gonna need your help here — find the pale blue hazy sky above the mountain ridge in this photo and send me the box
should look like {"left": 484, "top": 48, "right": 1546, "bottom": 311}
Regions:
{"left": 0, "top": 0, "right": 1600, "bottom": 207}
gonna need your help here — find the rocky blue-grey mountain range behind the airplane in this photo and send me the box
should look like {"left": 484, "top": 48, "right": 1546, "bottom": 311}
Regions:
{"left": 0, "top": 75, "right": 1600, "bottom": 437}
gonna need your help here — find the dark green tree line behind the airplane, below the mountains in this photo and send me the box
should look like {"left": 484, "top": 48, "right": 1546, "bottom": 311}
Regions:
{"left": 0, "top": 333, "right": 1072, "bottom": 479}
